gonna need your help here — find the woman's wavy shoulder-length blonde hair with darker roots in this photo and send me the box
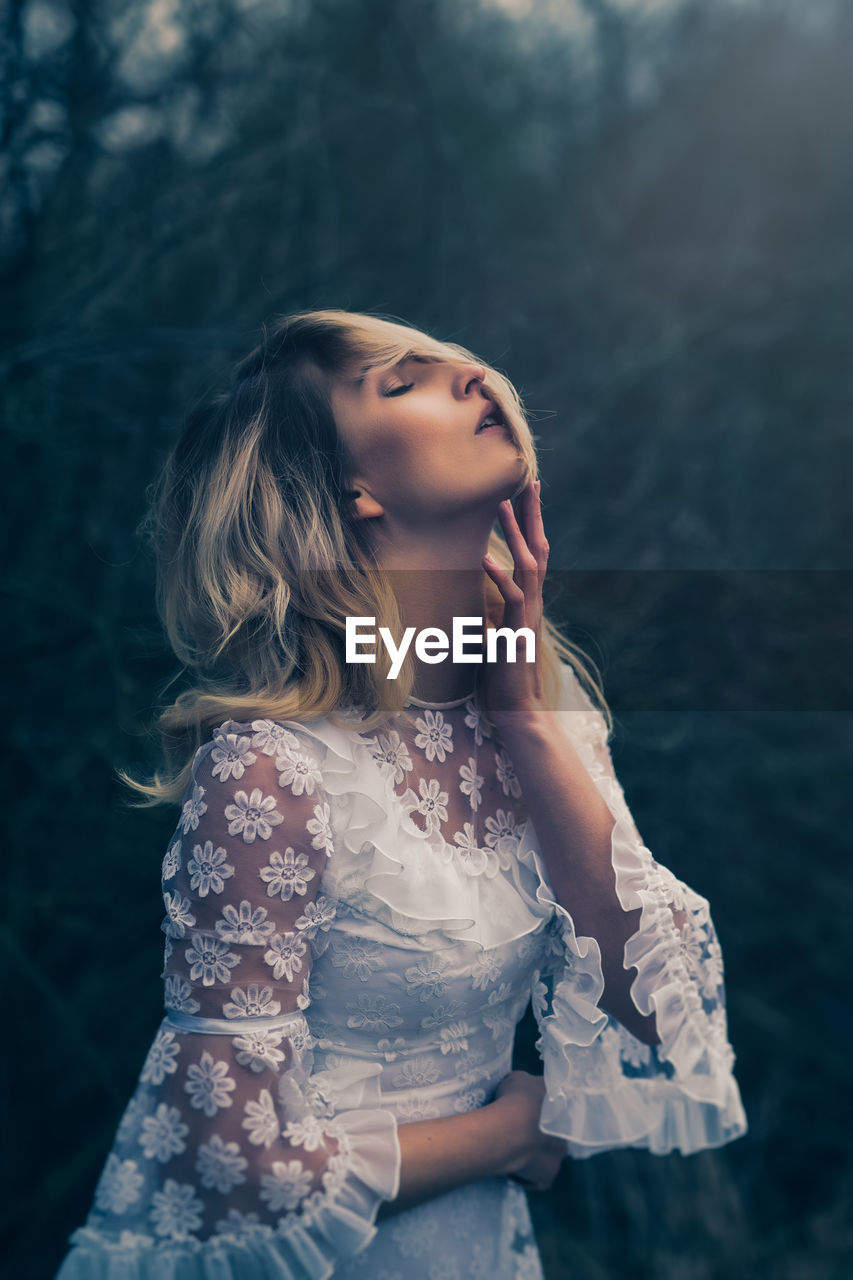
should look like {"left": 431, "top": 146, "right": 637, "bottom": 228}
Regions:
{"left": 117, "top": 310, "right": 611, "bottom": 808}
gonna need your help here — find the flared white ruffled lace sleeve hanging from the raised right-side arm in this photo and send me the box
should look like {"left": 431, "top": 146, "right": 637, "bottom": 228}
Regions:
{"left": 523, "top": 668, "right": 747, "bottom": 1158}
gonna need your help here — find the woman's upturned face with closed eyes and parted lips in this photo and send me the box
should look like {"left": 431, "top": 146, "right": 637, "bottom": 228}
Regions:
{"left": 326, "top": 356, "right": 526, "bottom": 527}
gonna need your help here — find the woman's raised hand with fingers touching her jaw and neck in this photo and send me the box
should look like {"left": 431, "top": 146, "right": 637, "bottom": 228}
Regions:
{"left": 483, "top": 481, "right": 549, "bottom": 723}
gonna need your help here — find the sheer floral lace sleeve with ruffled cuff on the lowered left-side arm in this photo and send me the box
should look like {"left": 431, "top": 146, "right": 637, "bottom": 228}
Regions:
{"left": 61, "top": 721, "right": 400, "bottom": 1280}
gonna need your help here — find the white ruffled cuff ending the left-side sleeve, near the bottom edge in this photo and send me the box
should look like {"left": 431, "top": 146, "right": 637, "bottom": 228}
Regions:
{"left": 56, "top": 1110, "right": 401, "bottom": 1280}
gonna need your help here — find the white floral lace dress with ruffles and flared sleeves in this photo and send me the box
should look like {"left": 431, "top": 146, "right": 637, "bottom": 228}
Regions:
{"left": 53, "top": 666, "right": 747, "bottom": 1280}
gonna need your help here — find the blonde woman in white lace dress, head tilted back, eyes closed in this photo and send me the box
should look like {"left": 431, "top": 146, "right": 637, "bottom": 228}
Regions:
{"left": 54, "top": 311, "right": 747, "bottom": 1280}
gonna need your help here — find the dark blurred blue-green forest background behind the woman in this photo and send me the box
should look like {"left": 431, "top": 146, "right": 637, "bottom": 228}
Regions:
{"left": 0, "top": 0, "right": 853, "bottom": 1280}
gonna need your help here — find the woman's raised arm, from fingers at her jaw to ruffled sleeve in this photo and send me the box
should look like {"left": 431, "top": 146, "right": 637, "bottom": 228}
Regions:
{"left": 484, "top": 488, "right": 747, "bottom": 1158}
